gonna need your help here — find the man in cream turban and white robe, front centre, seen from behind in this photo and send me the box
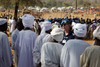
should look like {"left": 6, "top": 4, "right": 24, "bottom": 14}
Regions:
{"left": 41, "top": 28, "right": 63, "bottom": 67}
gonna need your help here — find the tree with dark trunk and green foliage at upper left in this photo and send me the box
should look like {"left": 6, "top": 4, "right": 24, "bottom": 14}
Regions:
{"left": 0, "top": 0, "right": 42, "bottom": 21}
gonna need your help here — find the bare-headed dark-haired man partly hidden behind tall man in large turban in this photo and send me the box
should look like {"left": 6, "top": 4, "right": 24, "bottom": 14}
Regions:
{"left": 11, "top": 19, "right": 24, "bottom": 67}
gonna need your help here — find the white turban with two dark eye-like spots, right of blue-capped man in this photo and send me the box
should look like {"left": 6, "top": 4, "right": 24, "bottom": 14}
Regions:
{"left": 73, "top": 23, "right": 87, "bottom": 37}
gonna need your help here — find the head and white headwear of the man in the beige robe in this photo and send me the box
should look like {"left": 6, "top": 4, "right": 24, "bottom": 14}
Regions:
{"left": 93, "top": 26, "right": 100, "bottom": 46}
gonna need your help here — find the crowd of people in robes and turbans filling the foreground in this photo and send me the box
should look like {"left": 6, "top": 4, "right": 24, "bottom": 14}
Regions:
{"left": 0, "top": 14, "right": 100, "bottom": 67}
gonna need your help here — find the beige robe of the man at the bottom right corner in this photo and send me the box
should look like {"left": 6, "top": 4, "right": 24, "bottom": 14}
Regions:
{"left": 80, "top": 46, "right": 100, "bottom": 67}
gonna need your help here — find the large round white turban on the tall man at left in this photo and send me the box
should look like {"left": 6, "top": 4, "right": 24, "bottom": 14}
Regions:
{"left": 22, "top": 14, "right": 34, "bottom": 28}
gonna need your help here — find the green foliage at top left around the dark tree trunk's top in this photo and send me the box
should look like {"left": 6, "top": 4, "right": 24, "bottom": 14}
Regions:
{"left": 0, "top": 0, "right": 43, "bottom": 8}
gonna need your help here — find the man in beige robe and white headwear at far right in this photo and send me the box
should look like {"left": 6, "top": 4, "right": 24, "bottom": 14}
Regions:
{"left": 80, "top": 26, "right": 100, "bottom": 67}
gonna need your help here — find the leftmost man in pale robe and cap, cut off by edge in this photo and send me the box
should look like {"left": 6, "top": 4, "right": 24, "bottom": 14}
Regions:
{"left": 0, "top": 19, "right": 13, "bottom": 67}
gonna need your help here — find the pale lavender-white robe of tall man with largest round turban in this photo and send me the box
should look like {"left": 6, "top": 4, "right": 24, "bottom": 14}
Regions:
{"left": 15, "top": 30, "right": 37, "bottom": 67}
